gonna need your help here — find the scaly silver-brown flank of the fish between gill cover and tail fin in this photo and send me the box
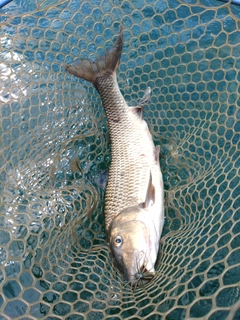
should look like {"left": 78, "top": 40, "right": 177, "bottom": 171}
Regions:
{"left": 95, "top": 75, "right": 158, "bottom": 231}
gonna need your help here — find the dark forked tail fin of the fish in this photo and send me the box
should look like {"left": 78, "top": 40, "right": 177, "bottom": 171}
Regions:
{"left": 65, "top": 26, "right": 123, "bottom": 84}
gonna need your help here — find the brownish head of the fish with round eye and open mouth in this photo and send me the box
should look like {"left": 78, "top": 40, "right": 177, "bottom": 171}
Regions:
{"left": 109, "top": 206, "right": 159, "bottom": 286}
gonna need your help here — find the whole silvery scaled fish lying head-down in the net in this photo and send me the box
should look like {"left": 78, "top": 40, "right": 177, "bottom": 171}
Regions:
{"left": 65, "top": 26, "right": 164, "bottom": 286}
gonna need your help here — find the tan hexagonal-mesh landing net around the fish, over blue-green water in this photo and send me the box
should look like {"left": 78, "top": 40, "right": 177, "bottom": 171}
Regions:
{"left": 0, "top": 0, "right": 240, "bottom": 320}
